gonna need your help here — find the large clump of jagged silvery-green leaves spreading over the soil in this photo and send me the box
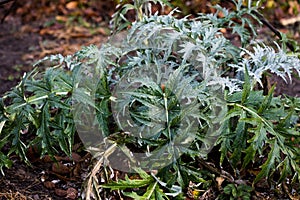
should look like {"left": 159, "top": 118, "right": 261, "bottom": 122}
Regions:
{"left": 0, "top": 0, "right": 300, "bottom": 199}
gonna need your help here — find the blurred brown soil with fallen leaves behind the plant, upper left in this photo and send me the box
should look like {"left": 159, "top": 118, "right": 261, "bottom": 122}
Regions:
{"left": 0, "top": 0, "right": 115, "bottom": 96}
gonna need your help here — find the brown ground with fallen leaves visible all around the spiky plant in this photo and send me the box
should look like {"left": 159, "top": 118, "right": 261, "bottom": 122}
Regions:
{"left": 0, "top": 0, "right": 300, "bottom": 199}
